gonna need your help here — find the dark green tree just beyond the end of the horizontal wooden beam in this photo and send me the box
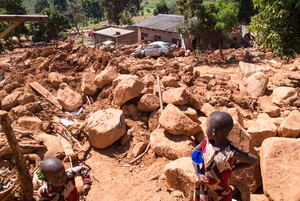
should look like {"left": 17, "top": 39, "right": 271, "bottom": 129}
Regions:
{"left": 31, "top": 6, "right": 71, "bottom": 41}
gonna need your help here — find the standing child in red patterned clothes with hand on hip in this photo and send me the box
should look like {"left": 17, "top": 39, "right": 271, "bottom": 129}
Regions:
{"left": 193, "top": 111, "right": 258, "bottom": 201}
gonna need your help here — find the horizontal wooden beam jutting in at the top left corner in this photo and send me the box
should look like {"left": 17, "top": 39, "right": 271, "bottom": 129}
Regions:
{"left": 0, "top": 15, "right": 48, "bottom": 22}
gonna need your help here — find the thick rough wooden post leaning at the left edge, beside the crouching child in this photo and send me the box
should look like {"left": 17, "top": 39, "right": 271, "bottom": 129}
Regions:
{"left": 0, "top": 110, "right": 33, "bottom": 201}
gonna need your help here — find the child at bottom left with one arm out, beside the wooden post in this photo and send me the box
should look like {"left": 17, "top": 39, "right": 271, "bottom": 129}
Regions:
{"left": 36, "top": 157, "right": 91, "bottom": 201}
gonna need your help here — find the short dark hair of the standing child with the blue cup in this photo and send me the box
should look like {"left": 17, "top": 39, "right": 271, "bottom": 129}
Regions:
{"left": 208, "top": 111, "right": 233, "bottom": 135}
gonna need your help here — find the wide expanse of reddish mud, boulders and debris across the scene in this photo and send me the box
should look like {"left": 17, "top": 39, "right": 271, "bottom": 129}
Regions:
{"left": 0, "top": 42, "right": 300, "bottom": 200}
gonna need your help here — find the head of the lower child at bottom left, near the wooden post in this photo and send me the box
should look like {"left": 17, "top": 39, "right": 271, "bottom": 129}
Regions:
{"left": 40, "top": 157, "right": 67, "bottom": 187}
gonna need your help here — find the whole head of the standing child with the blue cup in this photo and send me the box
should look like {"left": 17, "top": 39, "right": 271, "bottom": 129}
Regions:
{"left": 206, "top": 111, "right": 233, "bottom": 142}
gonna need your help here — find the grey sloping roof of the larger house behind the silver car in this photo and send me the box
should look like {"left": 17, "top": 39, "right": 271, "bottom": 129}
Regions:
{"left": 134, "top": 14, "right": 184, "bottom": 32}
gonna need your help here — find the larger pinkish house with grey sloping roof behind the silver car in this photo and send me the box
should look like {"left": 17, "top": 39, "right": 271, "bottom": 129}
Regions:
{"left": 133, "top": 14, "right": 189, "bottom": 46}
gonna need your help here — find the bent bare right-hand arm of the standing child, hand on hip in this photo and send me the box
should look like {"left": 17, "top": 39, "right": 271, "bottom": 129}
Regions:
{"left": 233, "top": 150, "right": 259, "bottom": 170}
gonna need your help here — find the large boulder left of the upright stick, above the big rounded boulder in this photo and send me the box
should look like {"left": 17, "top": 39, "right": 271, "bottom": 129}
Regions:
{"left": 113, "top": 77, "right": 144, "bottom": 106}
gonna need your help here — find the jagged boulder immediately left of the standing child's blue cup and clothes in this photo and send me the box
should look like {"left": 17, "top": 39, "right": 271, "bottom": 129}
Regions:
{"left": 164, "top": 157, "right": 197, "bottom": 200}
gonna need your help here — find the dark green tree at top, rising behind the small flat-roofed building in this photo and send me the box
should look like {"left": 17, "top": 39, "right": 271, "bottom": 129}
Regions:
{"left": 100, "top": 0, "right": 141, "bottom": 24}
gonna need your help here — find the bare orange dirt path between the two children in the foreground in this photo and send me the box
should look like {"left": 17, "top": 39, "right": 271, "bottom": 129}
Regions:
{"left": 86, "top": 147, "right": 178, "bottom": 201}
